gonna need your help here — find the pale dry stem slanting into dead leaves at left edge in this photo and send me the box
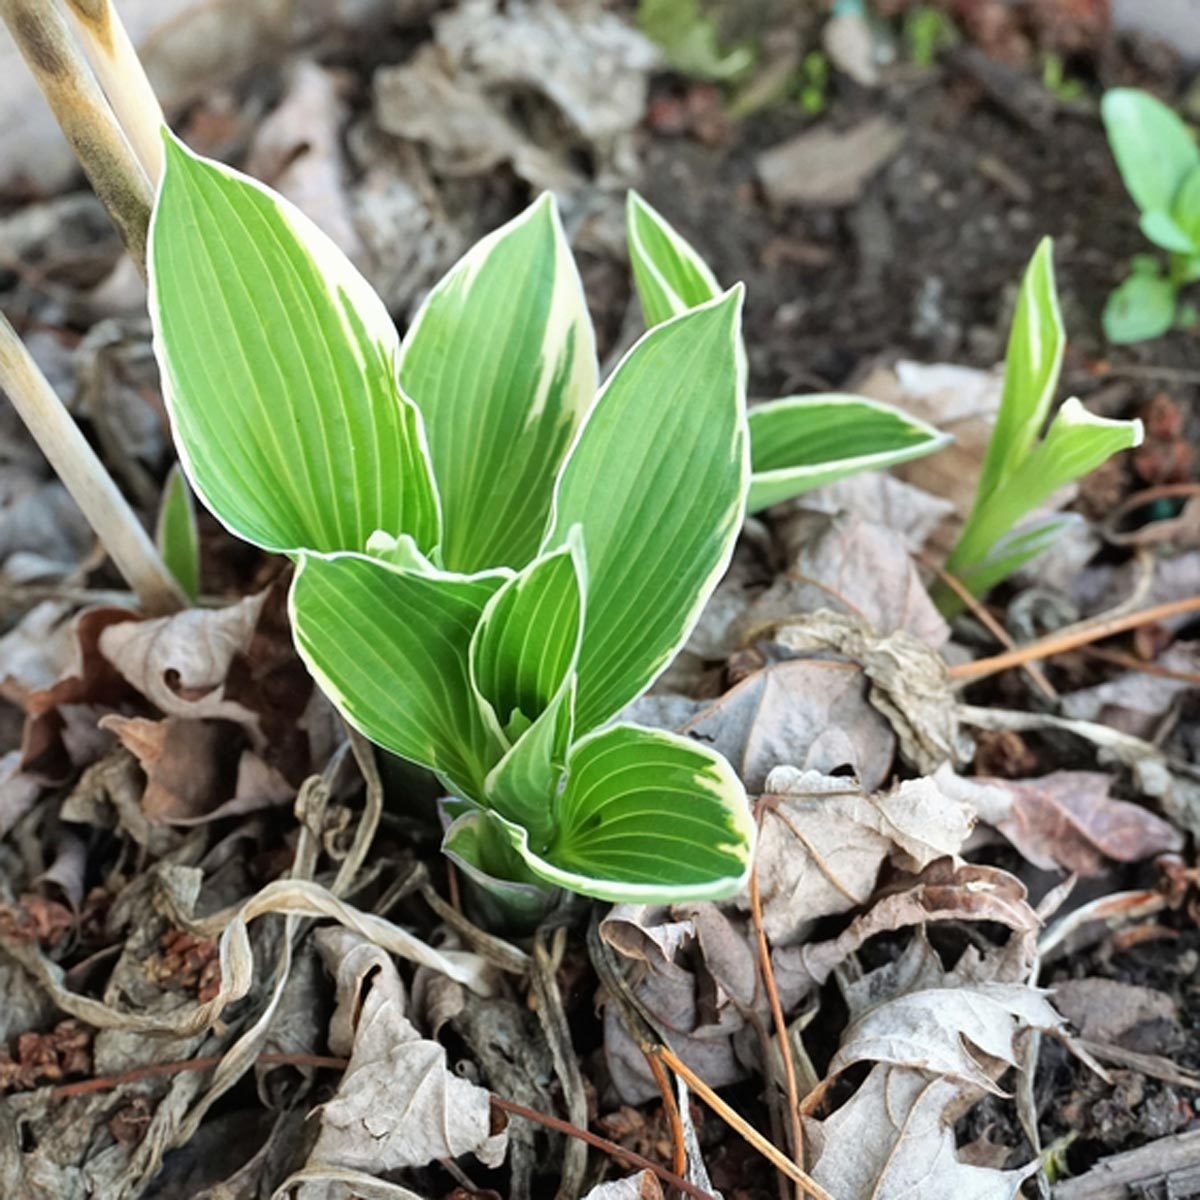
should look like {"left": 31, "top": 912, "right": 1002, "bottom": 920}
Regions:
{"left": 0, "top": 314, "right": 186, "bottom": 617}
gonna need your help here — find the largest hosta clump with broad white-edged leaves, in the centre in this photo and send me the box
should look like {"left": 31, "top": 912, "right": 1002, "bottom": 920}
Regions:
{"left": 150, "top": 139, "right": 754, "bottom": 912}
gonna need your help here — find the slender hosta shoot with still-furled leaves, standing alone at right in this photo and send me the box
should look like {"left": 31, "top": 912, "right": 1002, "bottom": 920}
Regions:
{"left": 936, "top": 238, "right": 1142, "bottom": 614}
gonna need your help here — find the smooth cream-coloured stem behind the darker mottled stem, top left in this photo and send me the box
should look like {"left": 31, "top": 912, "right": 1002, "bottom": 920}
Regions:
{"left": 66, "top": 0, "right": 166, "bottom": 187}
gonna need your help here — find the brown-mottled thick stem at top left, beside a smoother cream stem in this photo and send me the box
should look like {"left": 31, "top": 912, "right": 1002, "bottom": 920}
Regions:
{"left": 0, "top": 0, "right": 154, "bottom": 276}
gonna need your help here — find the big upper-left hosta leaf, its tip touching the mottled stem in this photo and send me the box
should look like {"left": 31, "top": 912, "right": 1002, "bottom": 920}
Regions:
{"left": 149, "top": 136, "right": 439, "bottom": 552}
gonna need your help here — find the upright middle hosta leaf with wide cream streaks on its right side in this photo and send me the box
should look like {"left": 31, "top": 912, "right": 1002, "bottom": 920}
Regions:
{"left": 400, "top": 194, "right": 596, "bottom": 571}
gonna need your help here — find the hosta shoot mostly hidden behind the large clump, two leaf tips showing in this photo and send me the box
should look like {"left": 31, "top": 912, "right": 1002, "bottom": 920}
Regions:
{"left": 626, "top": 192, "right": 950, "bottom": 512}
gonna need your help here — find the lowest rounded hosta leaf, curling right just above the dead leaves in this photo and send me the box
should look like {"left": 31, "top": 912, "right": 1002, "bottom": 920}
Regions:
{"left": 492, "top": 725, "right": 755, "bottom": 904}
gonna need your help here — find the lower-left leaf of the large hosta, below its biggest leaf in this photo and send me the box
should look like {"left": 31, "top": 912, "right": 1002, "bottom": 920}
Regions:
{"left": 289, "top": 554, "right": 510, "bottom": 799}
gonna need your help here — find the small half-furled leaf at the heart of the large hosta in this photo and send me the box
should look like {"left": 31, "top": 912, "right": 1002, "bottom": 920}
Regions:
{"left": 470, "top": 540, "right": 587, "bottom": 841}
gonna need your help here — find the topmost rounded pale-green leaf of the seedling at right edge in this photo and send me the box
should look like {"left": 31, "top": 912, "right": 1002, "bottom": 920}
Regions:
{"left": 1100, "top": 88, "right": 1200, "bottom": 212}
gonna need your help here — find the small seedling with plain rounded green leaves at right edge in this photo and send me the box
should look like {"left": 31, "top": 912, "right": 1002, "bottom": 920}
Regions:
{"left": 1102, "top": 88, "right": 1200, "bottom": 343}
